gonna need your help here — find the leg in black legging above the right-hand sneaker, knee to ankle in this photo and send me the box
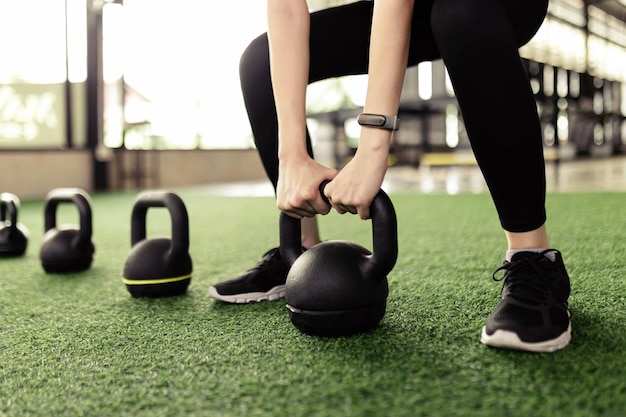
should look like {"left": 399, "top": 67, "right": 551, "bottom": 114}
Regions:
{"left": 432, "top": 0, "right": 546, "bottom": 231}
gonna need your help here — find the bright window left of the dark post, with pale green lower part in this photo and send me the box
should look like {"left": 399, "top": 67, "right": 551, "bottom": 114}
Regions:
{"left": 0, "top": 0, "right": 86, "bottom": 148}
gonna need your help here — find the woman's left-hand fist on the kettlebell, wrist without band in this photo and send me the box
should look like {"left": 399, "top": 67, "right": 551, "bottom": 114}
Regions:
{"left": 276, "top": 155, "right": 337, "bottom": 219}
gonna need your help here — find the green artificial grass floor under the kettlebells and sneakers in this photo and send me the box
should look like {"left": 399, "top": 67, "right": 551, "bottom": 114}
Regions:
{"left": 0, "top": 190, "right": 626, "bottom": 417}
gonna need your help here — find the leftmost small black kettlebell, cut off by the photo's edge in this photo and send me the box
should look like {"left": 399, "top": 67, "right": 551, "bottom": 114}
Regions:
{"left": 0, "top": 193, "right": 28, "bottom": 257}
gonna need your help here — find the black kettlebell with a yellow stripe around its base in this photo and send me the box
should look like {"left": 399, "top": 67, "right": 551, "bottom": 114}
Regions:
{"left": 123, "top": 191, "right": 193, "bottom": 297}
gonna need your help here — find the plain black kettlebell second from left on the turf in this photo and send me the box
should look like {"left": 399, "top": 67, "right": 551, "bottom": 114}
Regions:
{"left": 39, "top": 188, "right": 95, "bottom": 272}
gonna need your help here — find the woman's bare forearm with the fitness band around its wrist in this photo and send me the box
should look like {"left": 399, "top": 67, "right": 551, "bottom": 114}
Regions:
{"left": 359, "top": 0, "right": 413, "bottom": 152}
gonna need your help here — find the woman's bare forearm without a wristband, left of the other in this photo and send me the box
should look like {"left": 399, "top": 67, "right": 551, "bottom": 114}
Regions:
{"left": 267, "top": 0, "right": 310, "bottom": 160}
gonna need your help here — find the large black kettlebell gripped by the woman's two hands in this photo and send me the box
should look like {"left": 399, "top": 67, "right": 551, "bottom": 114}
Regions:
{"left": 280, "top": 183, "right": 398, "bottom": 336}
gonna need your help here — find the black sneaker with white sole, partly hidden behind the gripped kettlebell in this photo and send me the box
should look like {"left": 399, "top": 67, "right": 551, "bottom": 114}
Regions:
{"left": 209, "top": 248, "right": 289, "bottom": 304}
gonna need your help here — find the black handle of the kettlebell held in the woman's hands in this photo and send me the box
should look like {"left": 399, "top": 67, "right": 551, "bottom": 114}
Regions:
{"left": 279, "top": 181, "right": 398, "bottom": 276}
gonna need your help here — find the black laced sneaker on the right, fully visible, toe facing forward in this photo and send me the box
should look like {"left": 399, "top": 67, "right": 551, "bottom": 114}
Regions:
{"left": 480, "top": 249, "right": 571, "bottom": 352}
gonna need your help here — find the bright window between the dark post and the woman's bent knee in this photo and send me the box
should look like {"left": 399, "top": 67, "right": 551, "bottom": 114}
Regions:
{"left": 109, "top": 0, "right": 266, "bottom": 149}
